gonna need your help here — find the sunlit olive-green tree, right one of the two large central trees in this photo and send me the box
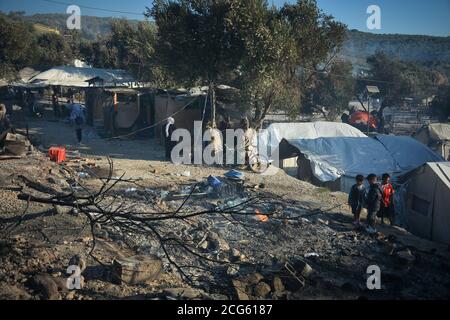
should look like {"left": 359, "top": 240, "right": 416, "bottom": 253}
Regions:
{"left": 239, "top": 0, "right": 346, "bottom": 127}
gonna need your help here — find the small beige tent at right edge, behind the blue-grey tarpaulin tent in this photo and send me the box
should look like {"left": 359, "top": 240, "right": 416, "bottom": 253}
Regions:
{"left": 413, "top": 123, "right": 450, "bottom": 161}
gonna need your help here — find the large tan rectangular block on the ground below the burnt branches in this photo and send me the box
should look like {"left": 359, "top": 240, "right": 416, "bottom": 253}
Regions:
{"left": 112, "top": 255, "right": 163, "bottom": 284}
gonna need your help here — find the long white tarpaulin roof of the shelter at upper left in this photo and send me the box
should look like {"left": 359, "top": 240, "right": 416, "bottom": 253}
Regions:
{"left": 29, "top": 66, "right": 135, "bottom": 87}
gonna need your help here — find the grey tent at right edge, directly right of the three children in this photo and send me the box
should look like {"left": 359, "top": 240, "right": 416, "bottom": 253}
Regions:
{"left": 396, "top": 162, "right": 450, "bottom": 245}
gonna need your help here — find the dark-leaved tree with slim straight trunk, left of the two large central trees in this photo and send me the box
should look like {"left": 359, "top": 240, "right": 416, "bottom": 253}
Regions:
{"left": 147, "top": 0, "right": 243, "bottom": 127}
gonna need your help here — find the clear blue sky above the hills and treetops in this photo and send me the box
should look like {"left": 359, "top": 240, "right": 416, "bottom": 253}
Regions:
{"left": 0, "top": 0, "right": 450, "bottom": 36}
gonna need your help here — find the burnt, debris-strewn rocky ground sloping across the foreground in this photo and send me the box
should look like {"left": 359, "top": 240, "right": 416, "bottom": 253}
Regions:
{"left": 0, "top": 105, "right": 450, "bottom": 300}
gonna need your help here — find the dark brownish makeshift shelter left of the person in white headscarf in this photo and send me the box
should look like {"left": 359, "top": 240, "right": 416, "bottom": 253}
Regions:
{"left": 85, "top": 87, "right": 154, "bottom": 137}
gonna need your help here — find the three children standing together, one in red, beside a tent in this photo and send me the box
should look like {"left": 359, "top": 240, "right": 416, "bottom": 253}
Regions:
{"left": 348, "top": 173, "right": 395, "bottom": 233}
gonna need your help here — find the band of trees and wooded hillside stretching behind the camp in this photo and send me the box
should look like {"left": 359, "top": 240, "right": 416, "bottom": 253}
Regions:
{"left": 0, "top": 6, "right": 450, "bottom": 124}
